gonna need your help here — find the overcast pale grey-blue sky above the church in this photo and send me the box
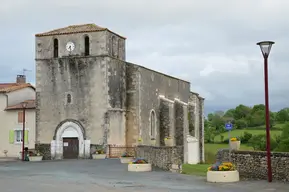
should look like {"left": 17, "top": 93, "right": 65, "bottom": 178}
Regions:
{"left": 0, "top": 0, "right": 289, "bottom": 113}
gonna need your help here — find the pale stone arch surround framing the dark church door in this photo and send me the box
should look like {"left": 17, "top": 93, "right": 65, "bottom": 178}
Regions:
{"left": 51, "top": 120, "right": 90, "bottom": 159}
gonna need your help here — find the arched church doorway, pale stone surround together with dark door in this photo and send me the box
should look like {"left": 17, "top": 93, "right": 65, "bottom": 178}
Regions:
{"left": 51, "top": 120, "right": 86, "bottom": 159}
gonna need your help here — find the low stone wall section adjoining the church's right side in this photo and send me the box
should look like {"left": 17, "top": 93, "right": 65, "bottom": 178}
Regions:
{"left": 136, "top": 146, "right": 184, "bottom": 170}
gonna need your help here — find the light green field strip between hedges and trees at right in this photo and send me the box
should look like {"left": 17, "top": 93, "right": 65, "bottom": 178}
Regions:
{"left": 214, "top": 129, "right": 282, "bottom": 142}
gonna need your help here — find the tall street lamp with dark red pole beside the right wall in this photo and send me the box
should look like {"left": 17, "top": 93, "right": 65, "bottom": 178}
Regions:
{"left": 257, "top": 41, "right": 274, "bottom": 182}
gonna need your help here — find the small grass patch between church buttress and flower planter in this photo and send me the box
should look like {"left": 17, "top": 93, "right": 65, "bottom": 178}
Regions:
{"left": 182, "top": 164, "right": 211, "bottom": 176}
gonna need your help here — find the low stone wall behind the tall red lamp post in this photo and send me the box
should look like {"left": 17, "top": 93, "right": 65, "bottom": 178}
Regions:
{"left": 216, "top": 149, "right": 289, "bottom": 182}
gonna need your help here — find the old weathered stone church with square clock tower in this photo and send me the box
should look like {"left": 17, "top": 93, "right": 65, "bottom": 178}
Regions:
{"left": 35, "top": 24, "right": 204, "bottom": 160}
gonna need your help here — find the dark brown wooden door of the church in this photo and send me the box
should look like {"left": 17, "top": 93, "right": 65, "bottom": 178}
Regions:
{"left": 63, "top": 138, "right": 79, "bottom": 159}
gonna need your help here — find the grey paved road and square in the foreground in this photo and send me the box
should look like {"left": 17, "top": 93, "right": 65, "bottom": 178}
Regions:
{"left": 0, "top": 159, "right": 289, "bottom": 192}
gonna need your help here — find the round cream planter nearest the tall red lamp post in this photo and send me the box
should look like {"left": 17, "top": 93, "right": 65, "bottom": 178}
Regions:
{"left": 207, "top": 170, "right": 240, "bottom": 183}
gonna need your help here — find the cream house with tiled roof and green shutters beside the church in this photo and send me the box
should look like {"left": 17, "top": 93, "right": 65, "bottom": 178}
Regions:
{"left": 0, "top": 75, "right": 35, "bottom": 157}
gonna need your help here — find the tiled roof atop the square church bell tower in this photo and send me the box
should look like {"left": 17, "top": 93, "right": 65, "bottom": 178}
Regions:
{"left": 35, "top": 23, "right": 125, "bottom": 39}
